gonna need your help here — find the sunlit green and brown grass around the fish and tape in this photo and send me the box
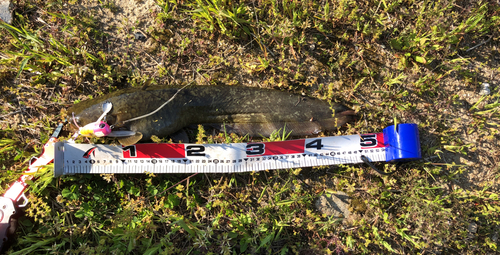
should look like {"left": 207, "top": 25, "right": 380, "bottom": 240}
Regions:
{"left": 0, "top": 0, "right": 500, "bottom": 254}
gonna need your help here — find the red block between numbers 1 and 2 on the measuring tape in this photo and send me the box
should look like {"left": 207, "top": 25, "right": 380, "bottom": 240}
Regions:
{"left": 122, "top": 143, "right": 186, "bottom": 158}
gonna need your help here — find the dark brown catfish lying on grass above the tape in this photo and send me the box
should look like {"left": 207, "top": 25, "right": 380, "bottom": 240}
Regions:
{"left": 68, "top": 86, "right": 355, "bottom": 140}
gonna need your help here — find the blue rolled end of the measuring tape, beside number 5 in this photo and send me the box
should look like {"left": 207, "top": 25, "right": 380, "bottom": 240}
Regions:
{"left": 384, "top": 124, "right": 422, "bottom": 162}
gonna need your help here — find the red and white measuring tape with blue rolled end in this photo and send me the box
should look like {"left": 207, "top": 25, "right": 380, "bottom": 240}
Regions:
{"left": 54, "top": 124, "right": 421, "bottom": 177}
